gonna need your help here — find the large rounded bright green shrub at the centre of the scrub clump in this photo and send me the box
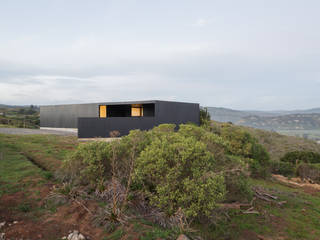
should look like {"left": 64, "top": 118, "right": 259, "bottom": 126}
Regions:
{"left": 135, "top": 133, "right": 226, "bottom": 217}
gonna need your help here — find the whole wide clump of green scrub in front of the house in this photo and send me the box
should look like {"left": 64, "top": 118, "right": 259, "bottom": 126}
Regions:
{"left": 63, "top": 124, "right": 269, "bottom": 223}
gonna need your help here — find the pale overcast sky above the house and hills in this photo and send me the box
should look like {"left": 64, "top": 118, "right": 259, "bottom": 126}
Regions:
{"left": 0, "top": 0, "right": 320, "bottom": 110}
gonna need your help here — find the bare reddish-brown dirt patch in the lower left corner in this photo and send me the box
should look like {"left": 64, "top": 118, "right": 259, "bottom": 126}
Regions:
{"left": 0, "top": 190, "right": 106, "bottom": 240}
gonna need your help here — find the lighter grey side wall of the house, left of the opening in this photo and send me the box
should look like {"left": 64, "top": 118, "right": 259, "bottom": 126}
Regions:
{"left": 40, "top": 103, "right": 99, "bottom": 128}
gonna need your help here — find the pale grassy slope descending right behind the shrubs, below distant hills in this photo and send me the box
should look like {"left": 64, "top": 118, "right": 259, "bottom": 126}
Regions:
{"left": 212, "top": 121, "right": 320, "bottom": 160}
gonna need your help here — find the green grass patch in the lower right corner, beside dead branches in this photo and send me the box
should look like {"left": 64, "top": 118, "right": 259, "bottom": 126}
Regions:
{"left": 198, "top": 180, "right": 320, "bottom": 240}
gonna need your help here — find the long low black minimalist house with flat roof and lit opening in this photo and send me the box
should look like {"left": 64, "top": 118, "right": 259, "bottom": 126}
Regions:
{"left": 40, "top": 100, "right": 200, "bottom": 138}
